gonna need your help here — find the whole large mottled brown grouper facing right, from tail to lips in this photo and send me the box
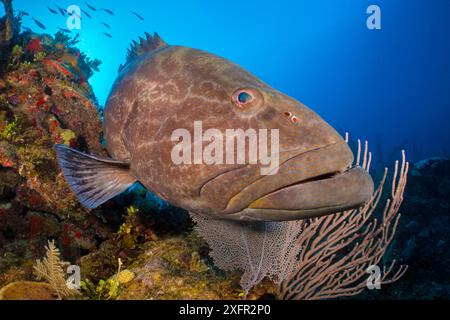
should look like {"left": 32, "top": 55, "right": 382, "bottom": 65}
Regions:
{"left": 55, "top": 34, "right": 373, "bottom": 221}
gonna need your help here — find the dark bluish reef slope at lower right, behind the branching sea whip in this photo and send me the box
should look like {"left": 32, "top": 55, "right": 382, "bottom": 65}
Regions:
{"left": 360, "top": 158, "right": 450, "bottom": 299}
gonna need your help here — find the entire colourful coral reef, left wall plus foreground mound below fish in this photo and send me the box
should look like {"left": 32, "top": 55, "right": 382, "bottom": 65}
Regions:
{"left": 0, "top": 20, "right": 412, "bottom": 299}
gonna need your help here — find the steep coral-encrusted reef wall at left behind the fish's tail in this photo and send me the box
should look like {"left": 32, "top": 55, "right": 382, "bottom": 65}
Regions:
{"left": 0, "top": 7, "right": 114, "bottom": 286}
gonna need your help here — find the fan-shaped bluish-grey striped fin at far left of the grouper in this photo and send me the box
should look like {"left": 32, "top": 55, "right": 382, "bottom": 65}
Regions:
{"left": 55, "top": 144, "right": 137, "bottom": 209}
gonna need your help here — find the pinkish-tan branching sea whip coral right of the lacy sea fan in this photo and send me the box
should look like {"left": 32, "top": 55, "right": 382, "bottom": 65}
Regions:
{"left": 279, "top": 141, "right": 409, "bottom": 300}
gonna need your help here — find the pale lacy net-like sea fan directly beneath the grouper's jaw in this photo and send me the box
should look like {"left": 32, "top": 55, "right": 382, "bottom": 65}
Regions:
{"left": 191, "top": 213, "right": 303, "bottom": 295}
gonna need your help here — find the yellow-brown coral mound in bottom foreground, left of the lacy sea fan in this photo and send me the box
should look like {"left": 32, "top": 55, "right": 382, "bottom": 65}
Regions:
{"left": 75, "top": 207, "right": 275, "bottom": 299}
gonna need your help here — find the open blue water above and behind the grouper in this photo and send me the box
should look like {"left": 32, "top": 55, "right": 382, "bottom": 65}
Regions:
{"left": 4, "top": 0, "right": 450, "bottom": 161}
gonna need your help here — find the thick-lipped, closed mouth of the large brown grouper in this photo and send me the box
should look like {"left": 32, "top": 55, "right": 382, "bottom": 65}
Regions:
{"left": 221, "top": 144, "right": 374, "bottom": 221}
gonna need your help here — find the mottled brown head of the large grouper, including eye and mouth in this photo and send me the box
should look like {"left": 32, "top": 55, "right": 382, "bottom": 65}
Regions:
{"left": 153, "top": 47, "right": 373, "bottom": 221}
